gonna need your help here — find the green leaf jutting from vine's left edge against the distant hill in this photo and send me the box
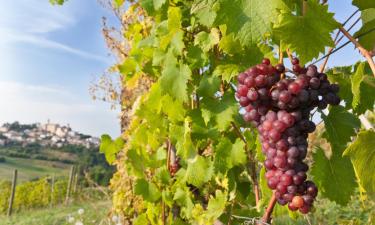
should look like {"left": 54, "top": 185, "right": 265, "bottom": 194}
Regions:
{"left": 99, "top": 134, "right": 124, "bottom": 164}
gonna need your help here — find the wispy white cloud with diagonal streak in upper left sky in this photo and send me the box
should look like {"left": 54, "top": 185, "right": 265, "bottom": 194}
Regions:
{"left": 0, "top": 0, "right": 109, "bottom": 63}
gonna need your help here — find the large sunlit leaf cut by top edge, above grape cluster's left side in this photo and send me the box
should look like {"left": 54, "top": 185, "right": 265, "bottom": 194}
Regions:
{"left": 215, "top": 0, "right": 280, "bottom": 46}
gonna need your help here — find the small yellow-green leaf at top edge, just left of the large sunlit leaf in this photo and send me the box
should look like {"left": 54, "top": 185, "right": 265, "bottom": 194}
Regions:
{"left": 190, "top": 0, "right": 217, "bottom": 27}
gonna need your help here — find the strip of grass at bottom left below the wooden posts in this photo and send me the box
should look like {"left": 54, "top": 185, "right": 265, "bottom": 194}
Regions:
{"left": 0, "top": 201, "right": 111, "bottom": 225}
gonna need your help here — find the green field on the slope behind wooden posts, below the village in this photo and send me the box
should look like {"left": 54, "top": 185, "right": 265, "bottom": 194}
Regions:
{"left": 0, "top": 157, "right": 70, "bottom": 182}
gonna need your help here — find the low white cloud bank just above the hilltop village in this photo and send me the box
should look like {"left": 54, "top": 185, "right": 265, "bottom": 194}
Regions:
{"left": 0, "top": 81, "right": 120, "bottom": 136}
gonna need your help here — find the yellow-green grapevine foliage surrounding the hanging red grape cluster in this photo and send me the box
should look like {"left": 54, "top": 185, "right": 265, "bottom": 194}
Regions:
{"left": 52, "top": 0, "right": 374, "bottom": 224}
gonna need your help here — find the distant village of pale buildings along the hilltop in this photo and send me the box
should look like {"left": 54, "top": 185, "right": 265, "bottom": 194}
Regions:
{"left": 0, "top": 121, "right": 99, "bottom": 148}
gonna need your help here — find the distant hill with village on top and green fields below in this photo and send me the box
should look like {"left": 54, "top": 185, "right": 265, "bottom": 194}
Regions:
{"left": 0, "top": 122, "right": 114, "bottom": 184}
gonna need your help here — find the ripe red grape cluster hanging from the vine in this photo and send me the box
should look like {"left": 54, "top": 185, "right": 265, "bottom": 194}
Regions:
{"left": 236, "top": 58, "right": 340, "bottom": 213}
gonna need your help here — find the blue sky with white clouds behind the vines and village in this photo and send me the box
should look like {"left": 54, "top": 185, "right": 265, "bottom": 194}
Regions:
{"left": 0, "top": 0, "right": 368, "bottom": 136}
